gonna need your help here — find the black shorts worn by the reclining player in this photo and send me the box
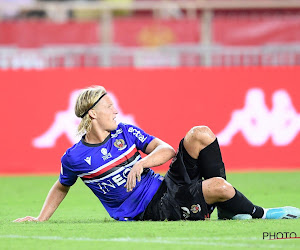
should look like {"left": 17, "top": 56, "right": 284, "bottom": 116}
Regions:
{"left": 135, "top": 139, "right": 215, "bottom": 221}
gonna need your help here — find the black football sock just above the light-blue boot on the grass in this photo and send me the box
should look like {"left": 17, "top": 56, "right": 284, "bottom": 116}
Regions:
{"left": 216, "top": 189, "right": 264, "bottom": 218}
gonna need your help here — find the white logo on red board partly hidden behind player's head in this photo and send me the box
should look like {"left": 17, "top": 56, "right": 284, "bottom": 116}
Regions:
{"left": 32, "top": 90, "right": 138, "bottom": 148}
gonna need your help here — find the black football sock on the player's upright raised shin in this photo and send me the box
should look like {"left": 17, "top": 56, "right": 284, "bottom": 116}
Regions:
{"left": 197, "top": 138, "right": 226, "bottom": 180}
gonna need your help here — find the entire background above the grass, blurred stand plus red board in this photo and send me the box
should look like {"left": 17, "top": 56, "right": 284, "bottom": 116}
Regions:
{"left": 0, "top": 0, "right": 300, "bottom": 174}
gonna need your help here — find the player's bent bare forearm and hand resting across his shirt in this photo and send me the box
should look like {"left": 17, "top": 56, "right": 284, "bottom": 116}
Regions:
{"left": 125, "top": 138, "right": 175, "bottom": 192}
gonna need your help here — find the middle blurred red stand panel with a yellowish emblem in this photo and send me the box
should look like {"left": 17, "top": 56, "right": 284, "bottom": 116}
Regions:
{"left": 113, "top": 17, "right": 201, "bottom": 47}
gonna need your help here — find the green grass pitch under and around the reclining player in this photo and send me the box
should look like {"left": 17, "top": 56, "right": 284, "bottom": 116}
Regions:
{"left": 0, "top": 171, "right": 300, "bottom": 250}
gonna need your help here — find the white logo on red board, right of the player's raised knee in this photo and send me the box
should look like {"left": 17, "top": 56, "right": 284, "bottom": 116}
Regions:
{"left": 217, "top": 88, "right": 300, "bottom": 146}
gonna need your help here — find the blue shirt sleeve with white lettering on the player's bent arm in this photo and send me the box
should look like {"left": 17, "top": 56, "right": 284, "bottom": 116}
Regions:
{"left": 124, "top": 124, "right": 155, "bottom": 153}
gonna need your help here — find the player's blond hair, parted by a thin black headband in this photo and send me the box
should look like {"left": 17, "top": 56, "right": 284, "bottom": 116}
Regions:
{"left": 75, "top": 86, "right": 106, "bottom": 135}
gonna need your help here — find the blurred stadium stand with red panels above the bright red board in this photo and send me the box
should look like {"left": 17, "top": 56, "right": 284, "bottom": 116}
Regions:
{"left": 0, "top": 0, "right": 300, "bottom": 69}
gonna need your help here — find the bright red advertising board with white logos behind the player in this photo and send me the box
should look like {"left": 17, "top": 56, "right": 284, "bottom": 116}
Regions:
{"left": 0, "top": 67, "right": 300, "bottom": 174}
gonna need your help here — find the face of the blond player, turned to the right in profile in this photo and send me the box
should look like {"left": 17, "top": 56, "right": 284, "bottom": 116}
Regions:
{"left": 94, "top": 95, "right": 118, "bottom": 131}
